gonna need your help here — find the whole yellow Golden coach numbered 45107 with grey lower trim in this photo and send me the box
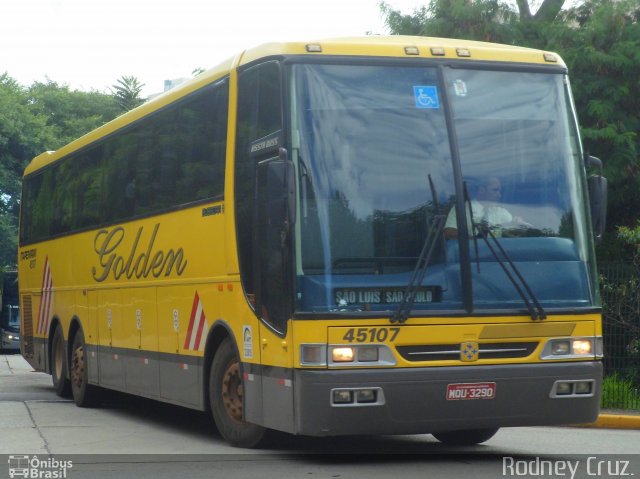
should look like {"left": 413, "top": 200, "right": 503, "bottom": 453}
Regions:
{"left": 18, "top": 36, "right": 606, "bottom": 447}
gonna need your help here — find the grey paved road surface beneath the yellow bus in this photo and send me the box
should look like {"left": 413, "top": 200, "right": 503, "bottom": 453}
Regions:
{"left": 0, "top": 355, "right": 640, "bottom": 479}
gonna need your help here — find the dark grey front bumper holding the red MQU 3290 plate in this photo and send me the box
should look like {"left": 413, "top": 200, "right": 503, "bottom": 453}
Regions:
{"left": 293, "top": 361, "right": 602, "bottom": 436}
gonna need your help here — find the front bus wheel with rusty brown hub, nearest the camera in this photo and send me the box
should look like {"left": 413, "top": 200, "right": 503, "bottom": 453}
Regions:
{"left": 209, "top": 338, "right": 265, "bottom": 448}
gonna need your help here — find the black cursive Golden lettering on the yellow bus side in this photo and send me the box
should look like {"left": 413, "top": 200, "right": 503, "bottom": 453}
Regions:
{"left": 92, "top": 224, "right": 187, "bottom": 282}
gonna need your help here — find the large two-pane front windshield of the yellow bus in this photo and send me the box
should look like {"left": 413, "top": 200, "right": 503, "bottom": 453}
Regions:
{"left": 290, "top": 64, "right": 597, "bottom": 314}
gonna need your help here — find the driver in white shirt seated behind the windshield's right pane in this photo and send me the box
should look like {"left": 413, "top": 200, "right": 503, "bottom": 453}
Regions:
{"left": 444, "top": 176, "right": 528, "bottom": 239}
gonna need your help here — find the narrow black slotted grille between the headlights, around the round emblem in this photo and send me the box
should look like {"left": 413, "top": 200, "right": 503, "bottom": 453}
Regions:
{"left": 397, "top": 342, "right": 538, "bottom": 362}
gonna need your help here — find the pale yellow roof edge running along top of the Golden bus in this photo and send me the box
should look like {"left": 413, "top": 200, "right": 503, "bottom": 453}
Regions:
{"left": 24, "top": 35, "right": 565, "bottom": 176}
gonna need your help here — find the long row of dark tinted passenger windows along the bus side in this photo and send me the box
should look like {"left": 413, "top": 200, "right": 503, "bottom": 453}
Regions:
{"left": 21, "top": 80, "right": 229, "bottom": 243}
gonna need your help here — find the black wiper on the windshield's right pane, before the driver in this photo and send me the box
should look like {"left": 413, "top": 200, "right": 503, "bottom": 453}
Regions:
{"left": 464, "top": 183, "right": 547, "bottom": 321}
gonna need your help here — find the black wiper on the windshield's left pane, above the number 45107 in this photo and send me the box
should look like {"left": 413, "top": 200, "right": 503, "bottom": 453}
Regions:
{"left": 390, "top": 175, "right": 446, "bottom": 323}
